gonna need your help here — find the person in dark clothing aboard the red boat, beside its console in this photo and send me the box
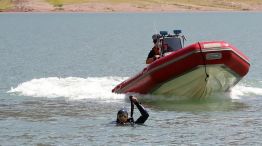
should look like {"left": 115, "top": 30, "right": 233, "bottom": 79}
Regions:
{"left": 146, "top": 34, "right": 161, "bottom": 64}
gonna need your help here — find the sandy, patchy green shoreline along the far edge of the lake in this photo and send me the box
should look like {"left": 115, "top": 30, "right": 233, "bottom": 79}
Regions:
{"left": 0, "top": 0, "right": 262, "bottom": 13}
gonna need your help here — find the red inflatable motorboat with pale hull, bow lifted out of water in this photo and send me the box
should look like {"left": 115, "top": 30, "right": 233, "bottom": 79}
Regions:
{"left": 112, "top": 31, "right": 250, "bottom": 97}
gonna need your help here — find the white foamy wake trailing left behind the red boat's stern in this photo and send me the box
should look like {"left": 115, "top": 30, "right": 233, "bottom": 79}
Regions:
{"left": 8, "top": 77, "right": 126, "bottom": 100}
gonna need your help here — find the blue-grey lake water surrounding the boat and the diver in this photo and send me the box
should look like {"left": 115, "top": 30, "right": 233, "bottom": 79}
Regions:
{"left": 0, "top": 12, "right": 262, "bottom": 146}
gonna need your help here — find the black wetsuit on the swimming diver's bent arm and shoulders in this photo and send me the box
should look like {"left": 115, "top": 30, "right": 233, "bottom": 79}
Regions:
{"left": 116, "top": 103, "right": 149, "bottom": 125}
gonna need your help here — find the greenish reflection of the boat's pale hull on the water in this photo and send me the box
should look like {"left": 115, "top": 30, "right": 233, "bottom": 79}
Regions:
{"left": 141, "top": 95, "right": 248, "bottom": 112}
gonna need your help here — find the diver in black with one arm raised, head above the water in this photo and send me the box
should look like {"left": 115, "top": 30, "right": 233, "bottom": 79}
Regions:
{"left": 116, "top": 96, "right": 149, "bottom": 125}
